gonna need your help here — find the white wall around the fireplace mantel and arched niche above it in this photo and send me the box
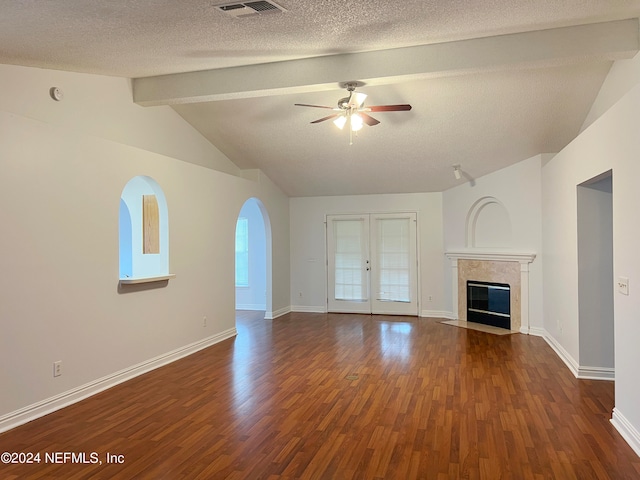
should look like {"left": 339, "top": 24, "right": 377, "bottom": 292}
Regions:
{"left": 442, "top": 155, "right": 543, "bottom": 331}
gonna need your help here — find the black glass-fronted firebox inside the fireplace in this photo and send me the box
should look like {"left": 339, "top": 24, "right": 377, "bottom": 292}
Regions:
{"left": 467, "top": 280, "right": 511, "bottom": 330}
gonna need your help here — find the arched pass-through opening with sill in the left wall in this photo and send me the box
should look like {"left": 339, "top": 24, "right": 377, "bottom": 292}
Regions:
{"left": 118, "top": 175, "right": 169, "bottom": 280}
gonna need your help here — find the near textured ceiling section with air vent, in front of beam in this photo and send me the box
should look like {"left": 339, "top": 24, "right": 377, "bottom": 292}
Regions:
{"left": 0, "top": 0, "right": 640, "bottom": 78}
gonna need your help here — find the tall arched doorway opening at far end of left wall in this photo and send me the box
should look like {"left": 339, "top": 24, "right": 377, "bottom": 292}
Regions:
{"left": 235, "top": 198, "right": 273, "bottom": 319}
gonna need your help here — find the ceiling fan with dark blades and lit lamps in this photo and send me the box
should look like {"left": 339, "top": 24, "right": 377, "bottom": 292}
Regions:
{"left": 294, "top": 82, "right": 411, "bottom": 144}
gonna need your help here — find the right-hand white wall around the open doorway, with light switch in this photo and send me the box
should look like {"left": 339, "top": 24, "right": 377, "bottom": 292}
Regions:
{"left": 542, "top": 80, "right": 640, "bottom": 454}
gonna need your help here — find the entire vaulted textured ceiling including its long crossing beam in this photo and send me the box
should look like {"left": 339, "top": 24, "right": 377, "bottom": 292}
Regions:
{"left": 0, "top": 0, "right": 640, "bottom": 196}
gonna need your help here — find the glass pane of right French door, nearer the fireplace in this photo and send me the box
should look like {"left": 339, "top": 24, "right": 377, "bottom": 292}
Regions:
{"left": 376, "top": 218, "right": 411, "bottom": 302}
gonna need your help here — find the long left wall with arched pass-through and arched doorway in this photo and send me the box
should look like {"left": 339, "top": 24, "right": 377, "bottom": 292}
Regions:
{"left": 0, "top": 62, "right": 290, "bottom": 430}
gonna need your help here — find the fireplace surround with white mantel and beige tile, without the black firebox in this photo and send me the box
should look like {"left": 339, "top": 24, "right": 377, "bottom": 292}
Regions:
{"left": 446, "top": 250, "right": 536, "bottom": 333}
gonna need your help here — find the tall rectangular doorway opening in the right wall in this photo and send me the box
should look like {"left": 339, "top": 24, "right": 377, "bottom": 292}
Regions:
{"left": 577, "top": 171, "right": 615, "bottom": 380}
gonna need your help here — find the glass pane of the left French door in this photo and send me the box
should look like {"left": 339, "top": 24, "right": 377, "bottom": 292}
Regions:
{"left": 333, "top": 219, "right": 368, "bottom": 301}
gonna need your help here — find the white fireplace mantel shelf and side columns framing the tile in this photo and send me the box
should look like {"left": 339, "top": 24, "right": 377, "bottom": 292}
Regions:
{"left": 445, "top": 248, "right": 536, "bottom": 334}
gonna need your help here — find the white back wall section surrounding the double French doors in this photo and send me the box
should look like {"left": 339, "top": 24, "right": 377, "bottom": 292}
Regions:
{"left": 290, "top": 193, "right": 444, "bottom": 316}
